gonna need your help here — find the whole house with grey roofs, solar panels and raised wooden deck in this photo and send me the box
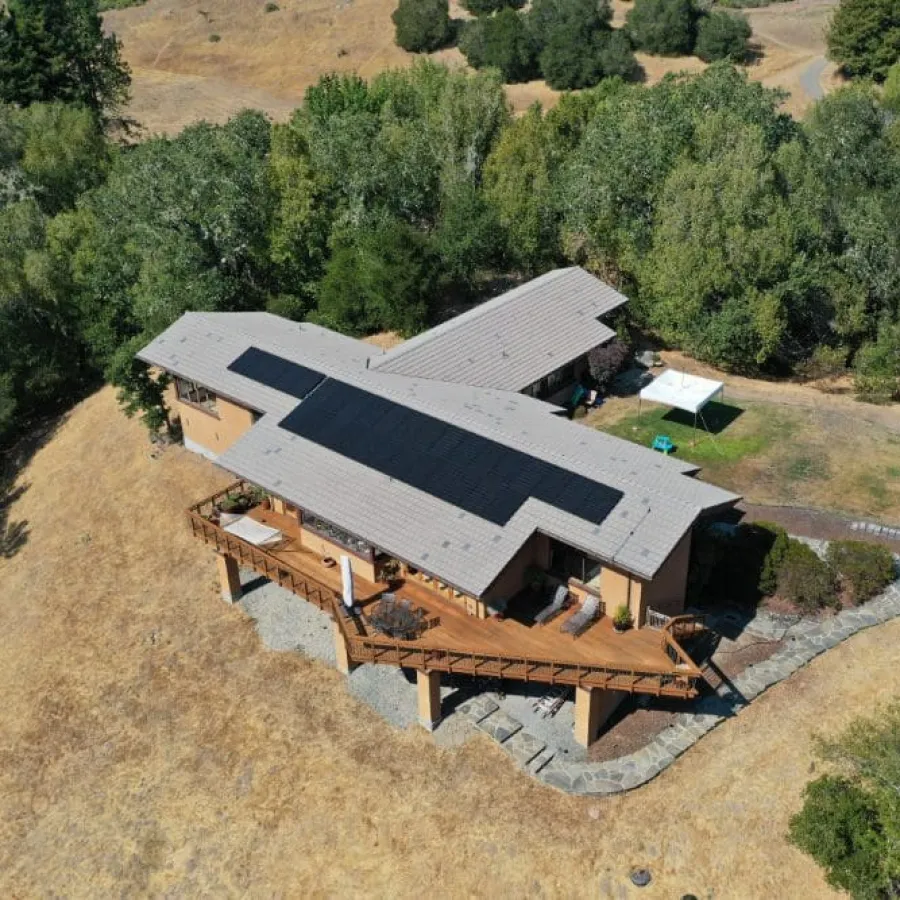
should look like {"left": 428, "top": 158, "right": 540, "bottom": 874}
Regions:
{"left": 139, "top": 268, "right": 738, "bottom": 743}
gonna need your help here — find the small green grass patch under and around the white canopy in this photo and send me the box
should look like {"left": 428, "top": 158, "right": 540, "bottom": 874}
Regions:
{"left": 605, "top": 403, "right": 772, "bottom": 466}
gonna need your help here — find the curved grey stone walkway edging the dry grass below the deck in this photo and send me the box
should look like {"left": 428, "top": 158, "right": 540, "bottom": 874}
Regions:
{"left": 459, "top": 579, "right": 900, "bottom": 795}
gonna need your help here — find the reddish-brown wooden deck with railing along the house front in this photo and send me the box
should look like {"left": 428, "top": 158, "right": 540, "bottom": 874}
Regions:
{"left": 188, "top": 488, "right": 701, "bottom": 697}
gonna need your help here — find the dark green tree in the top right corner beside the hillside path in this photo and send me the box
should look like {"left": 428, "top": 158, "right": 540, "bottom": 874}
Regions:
{"left": 827, "top": 0, "right": 900, "bottom": 81}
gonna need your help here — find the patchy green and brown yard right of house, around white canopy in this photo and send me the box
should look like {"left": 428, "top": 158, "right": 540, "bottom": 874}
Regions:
{"left": 584, "top": 397, "right": 900, "bottom": 524}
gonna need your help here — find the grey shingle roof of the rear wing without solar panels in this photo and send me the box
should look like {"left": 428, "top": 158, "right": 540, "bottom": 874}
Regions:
{"left": 372, "top": 267, "right": 626, "bottom": 391}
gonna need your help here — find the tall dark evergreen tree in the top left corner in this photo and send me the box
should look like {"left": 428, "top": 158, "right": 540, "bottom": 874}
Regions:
{"left": 0, "top": 0, "right": 131, "bottom": 121}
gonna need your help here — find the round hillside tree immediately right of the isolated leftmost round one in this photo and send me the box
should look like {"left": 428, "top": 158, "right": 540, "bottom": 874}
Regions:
{"left": 459, "top": 8, "right": 538, "bottom": 83}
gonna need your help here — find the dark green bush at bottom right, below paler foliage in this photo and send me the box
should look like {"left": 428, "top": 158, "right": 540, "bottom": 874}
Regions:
{"left": 790, "top": 775, "right": 890, "bottom": 898}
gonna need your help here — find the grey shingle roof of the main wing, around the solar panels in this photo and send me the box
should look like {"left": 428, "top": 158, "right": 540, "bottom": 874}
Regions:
{"left": 139, "top": 294, "right": 737, "bottom": 596}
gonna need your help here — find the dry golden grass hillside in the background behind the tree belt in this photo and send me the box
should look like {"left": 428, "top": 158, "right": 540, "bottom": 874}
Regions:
{"left": 104, "top": 0, "right": 836, "bottom": 133}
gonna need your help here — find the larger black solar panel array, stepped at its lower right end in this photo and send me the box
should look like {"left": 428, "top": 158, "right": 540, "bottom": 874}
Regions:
{"left": 279, "top": 378, "right": 622, "bottom": 525}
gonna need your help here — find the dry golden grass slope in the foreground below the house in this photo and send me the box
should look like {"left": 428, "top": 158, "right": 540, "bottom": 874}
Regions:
{"left": 0, "top": 389, "right": 900, "bottom": 900}
